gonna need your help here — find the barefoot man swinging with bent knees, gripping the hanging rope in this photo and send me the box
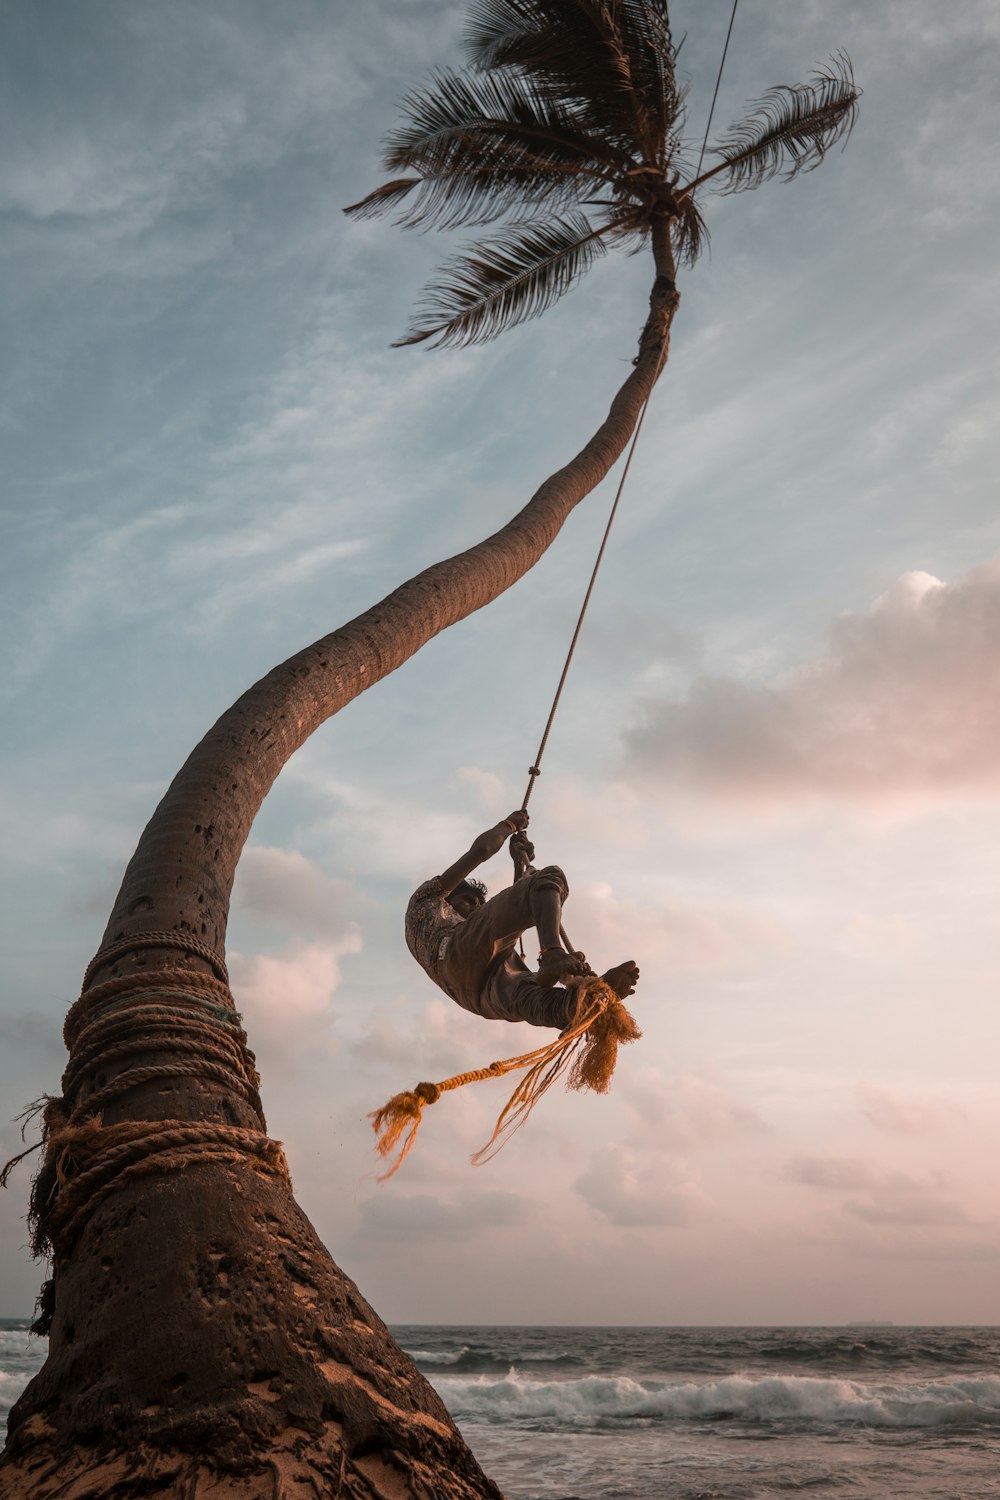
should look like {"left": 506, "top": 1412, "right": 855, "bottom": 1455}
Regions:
{"left": 406, "top": 810, "right": 639, "bottom": 1031}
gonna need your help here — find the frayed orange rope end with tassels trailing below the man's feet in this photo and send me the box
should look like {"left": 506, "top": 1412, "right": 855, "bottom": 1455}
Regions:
{"left": 369, "top": 975, "right": 642, "bottom": 1182}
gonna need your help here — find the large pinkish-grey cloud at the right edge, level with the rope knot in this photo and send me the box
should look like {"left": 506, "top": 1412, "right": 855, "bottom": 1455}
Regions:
{"left": 627, "top": 560, "right": 1000, "bottom": 804}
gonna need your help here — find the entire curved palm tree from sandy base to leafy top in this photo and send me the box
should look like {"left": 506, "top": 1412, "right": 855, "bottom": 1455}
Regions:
{"left": 0, "top": 0, "right": 858, "bottom": 1500}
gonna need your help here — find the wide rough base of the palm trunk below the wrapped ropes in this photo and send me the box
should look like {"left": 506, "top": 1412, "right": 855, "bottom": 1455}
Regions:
{"left": 0, "top": 1163, "right": 501, "bottom": 1500}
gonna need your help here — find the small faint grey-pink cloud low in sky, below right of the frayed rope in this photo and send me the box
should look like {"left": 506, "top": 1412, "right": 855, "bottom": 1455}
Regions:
{"left": 573, "top": 1146, "right": 708, "bottom": 1229}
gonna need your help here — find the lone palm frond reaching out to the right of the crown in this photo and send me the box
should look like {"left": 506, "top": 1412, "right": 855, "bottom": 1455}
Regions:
{"left": 690, "top": 53, "right": 861, "bottom": 192}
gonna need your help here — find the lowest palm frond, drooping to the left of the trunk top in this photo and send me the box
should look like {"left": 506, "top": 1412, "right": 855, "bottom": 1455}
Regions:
{"left": 397, "top": 213, "right": 609, "bottom": 348}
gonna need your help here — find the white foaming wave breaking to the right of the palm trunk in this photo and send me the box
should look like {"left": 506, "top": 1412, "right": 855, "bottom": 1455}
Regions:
{"left": 435, "top": 1368, "right": 1000, "bottom": 1430}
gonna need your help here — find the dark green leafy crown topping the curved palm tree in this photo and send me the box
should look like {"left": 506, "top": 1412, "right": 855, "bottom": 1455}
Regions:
{"left": 345, "top": 0, "right": 861, "bottom": 347}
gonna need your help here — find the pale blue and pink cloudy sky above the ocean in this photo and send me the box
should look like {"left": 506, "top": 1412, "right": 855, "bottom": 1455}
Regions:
{"left": 0, "top": 0, "right": 1000, "bottom": 1325}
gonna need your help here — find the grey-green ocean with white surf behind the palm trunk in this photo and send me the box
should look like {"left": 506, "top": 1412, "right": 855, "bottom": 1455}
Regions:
{"left": 0, "top": 1320, "right": 1000, "bottom": 1500}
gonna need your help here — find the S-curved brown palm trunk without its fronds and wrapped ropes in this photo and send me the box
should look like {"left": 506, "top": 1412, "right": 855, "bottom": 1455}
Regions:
{"left": 0, "top": 234, "right": 679, "bottom": 1500}
